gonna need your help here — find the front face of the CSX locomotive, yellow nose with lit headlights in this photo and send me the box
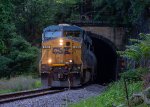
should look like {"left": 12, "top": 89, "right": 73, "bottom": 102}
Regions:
{"left": 40, "top": 24, "right": 82, "bottom": 87}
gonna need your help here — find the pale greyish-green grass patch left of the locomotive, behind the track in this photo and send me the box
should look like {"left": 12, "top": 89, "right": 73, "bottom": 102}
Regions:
{"left": 0, "top": 76, "right": 41, "bottom": 94}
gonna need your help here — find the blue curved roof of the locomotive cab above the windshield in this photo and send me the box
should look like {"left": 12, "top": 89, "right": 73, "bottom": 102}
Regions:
{"left": 43, "top": 24, "right": 83, "bottom": 32}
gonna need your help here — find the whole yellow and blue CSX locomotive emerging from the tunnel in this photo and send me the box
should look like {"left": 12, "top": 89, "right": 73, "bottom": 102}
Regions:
{"left": 40, "top": 24, "right": 96, "bottom": 87}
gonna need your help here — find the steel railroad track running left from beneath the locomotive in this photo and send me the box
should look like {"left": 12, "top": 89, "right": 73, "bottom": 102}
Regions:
{"left": 0, "top": 88, "right": 65, "bottom": 104}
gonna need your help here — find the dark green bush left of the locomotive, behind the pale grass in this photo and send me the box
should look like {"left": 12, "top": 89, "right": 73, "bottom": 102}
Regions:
{"left": 0, "top": 36, "right": 39, "bottom": 78}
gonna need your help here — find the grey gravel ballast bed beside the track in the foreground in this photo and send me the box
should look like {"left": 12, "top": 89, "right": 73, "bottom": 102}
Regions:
{"left": 0, "top": 84, "right": 105, "bottom": 107}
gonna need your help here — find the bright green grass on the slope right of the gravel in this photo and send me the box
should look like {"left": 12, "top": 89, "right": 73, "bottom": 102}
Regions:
{"left": 70, "top": 80, "right": 144, "bottom": 107}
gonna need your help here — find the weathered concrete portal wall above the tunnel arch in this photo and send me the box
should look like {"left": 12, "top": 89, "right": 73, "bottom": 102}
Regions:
{"left": 82, "top": 26, "right": 125, "bottom": 50}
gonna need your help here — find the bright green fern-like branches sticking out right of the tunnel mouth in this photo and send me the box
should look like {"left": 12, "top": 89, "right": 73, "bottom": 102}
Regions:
{"left": 119, "top": 33, "right": 150, "bottom": 62}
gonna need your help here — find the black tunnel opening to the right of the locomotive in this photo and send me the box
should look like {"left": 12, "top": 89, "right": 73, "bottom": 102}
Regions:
{"left": 92, "top": 37, "right": 117, "bottom": 84}
